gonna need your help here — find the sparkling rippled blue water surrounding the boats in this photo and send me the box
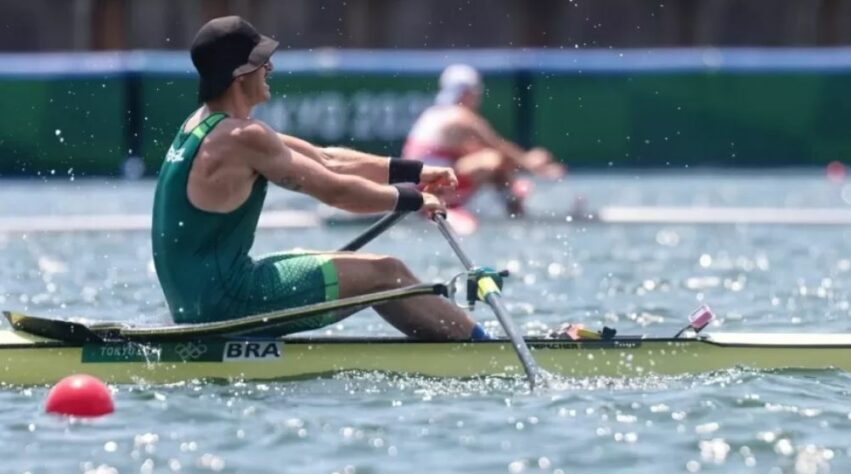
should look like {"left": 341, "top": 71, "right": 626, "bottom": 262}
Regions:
{"left": 0, "top": 171, "right": 851, "bottom": 473}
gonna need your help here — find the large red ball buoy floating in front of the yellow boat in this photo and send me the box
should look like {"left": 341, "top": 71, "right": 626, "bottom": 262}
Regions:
{"left": 45, "top": 374, "right": 115, "bottom": 416}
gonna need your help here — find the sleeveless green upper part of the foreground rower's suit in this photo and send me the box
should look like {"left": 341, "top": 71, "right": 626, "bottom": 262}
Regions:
{"left": 151, "top": 113, "right": 267, "bottom": 323}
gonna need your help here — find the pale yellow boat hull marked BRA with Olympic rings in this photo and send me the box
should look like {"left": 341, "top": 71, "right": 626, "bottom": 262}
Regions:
{"left": 0, "top": 331, "right": 851, "bottom": 385}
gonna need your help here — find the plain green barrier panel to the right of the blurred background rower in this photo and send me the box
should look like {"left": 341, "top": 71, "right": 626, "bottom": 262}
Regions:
{"left": 530, "top": 73, "right": 851, "bottom": 168}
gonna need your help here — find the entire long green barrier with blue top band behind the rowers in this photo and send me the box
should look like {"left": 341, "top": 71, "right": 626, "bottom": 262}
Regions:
{"left": 0, "top": 48, "right": 851, "bottom": 176}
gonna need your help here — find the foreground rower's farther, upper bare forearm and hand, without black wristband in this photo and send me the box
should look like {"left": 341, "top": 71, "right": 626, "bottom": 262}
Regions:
{"left": 278, "top": 134, "right": 458, "bottom": 189}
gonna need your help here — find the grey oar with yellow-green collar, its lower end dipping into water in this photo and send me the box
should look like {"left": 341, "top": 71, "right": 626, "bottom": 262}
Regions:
{"left": 433, "top": 214, "right": 539, "bottom": 389}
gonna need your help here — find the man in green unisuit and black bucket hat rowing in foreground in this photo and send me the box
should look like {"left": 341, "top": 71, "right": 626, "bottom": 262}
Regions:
{"left": 152, "top": 16, "right": 487, "bottom": 340}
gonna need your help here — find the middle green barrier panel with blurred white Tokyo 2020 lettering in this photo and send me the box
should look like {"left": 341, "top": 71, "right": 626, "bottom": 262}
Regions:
{"left": 141, "top": 73, "right": 517, "bottom": 173}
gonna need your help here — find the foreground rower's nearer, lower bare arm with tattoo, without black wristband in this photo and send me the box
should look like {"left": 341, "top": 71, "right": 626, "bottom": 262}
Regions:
{"left": 234, "top": 122, "right": 443, "bottom": 213}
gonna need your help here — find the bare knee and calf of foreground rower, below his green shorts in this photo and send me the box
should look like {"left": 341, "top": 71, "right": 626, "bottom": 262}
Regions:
{"left": 330, "top": 253, "right": 476, "bottom": 340}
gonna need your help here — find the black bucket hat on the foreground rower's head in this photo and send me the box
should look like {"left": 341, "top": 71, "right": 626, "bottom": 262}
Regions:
{"left": 191, "top": 16, "right": 278, "bottom": 102}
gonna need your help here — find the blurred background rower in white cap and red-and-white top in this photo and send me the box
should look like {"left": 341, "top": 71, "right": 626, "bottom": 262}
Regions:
{"left": 402, "top": 64, "right": 566, "bottom": 215}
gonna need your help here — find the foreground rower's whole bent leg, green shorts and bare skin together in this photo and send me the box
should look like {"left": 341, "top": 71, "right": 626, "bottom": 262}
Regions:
{"left": 216, "top": 251, "right": 486, "bottom": 340}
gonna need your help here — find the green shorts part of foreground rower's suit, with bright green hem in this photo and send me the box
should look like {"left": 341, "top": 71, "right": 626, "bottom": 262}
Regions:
{"left": 211, "top": 252, "right": 348, "bottom": 337}
